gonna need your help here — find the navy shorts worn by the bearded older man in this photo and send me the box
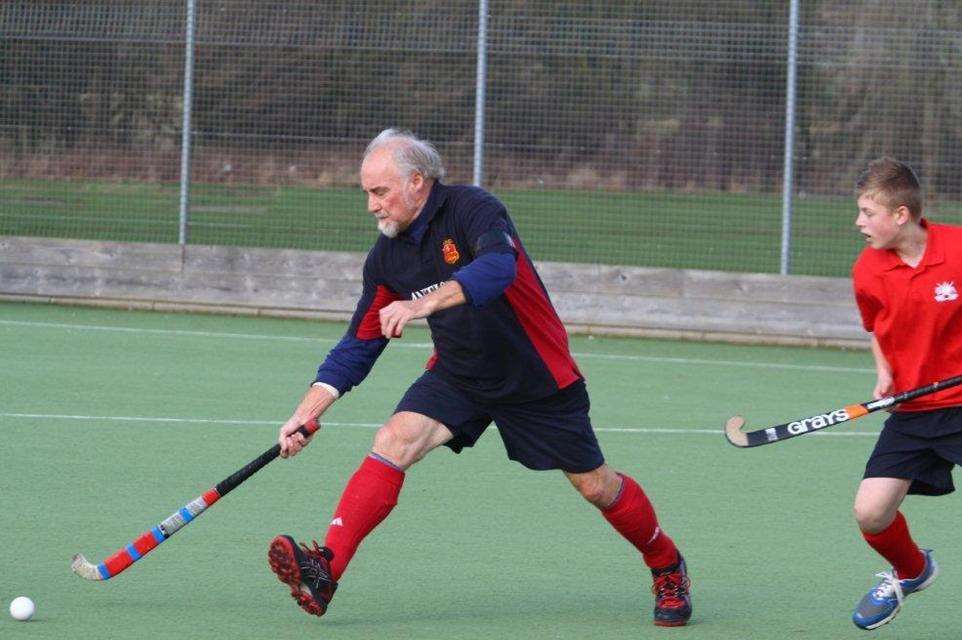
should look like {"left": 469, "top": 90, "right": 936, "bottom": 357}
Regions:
{"left": 395, "top": 371, "right": 605, "bottom": 473}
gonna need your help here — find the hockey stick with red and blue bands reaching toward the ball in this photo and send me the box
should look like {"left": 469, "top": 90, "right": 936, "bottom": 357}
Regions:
{"left": 70, "top": 419, "right": 320, "bottom": 580}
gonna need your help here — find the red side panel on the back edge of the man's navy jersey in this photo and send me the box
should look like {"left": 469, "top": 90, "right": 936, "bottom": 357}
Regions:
{"left": 504, "top": 246, "right": 582, "bottom": 389}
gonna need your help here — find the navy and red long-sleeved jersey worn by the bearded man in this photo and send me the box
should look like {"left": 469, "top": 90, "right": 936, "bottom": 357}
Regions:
{"left": 315, "top": 182, "right": 582, "bottom": 403}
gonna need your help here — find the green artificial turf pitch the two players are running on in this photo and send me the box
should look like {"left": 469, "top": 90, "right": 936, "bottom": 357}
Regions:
{"left": 0, "top": 303, "right": 962, "bottom": 640}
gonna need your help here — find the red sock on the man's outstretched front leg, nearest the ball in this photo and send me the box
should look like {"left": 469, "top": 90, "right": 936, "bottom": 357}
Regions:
{"left": 324, "top": 456, "right": 404, "bottom": 580}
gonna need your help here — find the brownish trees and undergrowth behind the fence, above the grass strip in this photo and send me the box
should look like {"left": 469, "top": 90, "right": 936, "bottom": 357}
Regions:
{"left": 0, "top": 0, "right": 962, "bottom": 194}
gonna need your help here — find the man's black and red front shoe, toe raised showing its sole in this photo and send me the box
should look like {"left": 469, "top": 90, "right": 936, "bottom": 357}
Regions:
{"left": 267, "top": 535, "right": 337, "bottom": 616}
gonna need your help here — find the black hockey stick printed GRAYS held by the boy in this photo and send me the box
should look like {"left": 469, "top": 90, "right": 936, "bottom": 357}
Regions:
{"left": 725, "top": 376, "right": 962, "bottom": 447}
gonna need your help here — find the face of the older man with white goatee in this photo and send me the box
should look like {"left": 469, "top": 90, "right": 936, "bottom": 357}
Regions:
{"left": 361, "top": 147, "right": 424, "bottom": 238}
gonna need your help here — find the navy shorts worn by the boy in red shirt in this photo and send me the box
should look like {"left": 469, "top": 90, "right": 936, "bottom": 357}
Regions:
{"left": 863, "top": 407, "right": 962, "bottom": 496}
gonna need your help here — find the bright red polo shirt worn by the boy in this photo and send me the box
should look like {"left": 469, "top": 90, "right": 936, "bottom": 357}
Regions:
{"left": 852, "top": 219, "right": 962, "bottom": 411}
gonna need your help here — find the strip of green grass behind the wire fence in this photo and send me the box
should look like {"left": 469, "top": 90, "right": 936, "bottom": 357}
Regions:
{"left": 9, "top": 180, "right": 944, "bottom": 276}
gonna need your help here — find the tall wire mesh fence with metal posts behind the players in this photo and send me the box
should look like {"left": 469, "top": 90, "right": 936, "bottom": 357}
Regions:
{"left": 0, "top": 0, "right": 962, "bottom": 275}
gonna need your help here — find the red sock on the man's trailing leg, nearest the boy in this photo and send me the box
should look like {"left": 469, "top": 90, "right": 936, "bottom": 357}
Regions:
{"left": 601, "top": 474, "right": 678, "bottom": 569}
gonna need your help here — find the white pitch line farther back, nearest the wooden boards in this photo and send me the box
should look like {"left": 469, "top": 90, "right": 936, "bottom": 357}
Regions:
{"left": 0, "top": 320, "right": 875, "bottom": 373}
